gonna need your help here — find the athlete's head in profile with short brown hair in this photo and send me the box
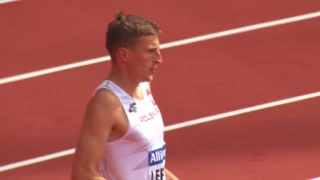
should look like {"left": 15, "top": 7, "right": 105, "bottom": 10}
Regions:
{"left": 106, "top": 11, "right": 162, "bottom": 81}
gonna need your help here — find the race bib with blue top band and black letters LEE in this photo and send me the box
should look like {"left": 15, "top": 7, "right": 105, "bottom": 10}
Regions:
{"left": 149, "top": 145, "right": 166, "bottom": 180}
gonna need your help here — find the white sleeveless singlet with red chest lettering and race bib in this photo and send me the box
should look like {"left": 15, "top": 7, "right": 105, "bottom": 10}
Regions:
{"left": 95, "top": 80, "right": 166, "bottom": 180}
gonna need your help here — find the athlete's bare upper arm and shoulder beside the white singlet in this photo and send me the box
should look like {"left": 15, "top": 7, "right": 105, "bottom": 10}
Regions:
{"left": 71, "top": 90, "right": 122, "bottom": 180}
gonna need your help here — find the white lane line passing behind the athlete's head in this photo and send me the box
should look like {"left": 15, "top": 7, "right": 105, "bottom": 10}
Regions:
{"left": 0, "top": 11, "right": 320, "bottom": 85}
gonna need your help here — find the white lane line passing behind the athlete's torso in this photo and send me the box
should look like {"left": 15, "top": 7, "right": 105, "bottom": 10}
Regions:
{"left": 0, "top": 91, "right": 320, "bottom": 172}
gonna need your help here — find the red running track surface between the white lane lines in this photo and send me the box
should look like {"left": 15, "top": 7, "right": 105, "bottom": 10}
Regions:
{"left": 0, "top": 0, "right": 320, "bottom": 180}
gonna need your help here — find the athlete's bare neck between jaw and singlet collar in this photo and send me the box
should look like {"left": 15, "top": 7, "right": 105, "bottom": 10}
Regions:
{"left": 107, "top": 68, "right": 143, "bottom": 100}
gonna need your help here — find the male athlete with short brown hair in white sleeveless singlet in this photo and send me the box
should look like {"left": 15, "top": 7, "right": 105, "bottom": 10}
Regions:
{"left": 72, "top": 12, "right": 178, "bottom": 180}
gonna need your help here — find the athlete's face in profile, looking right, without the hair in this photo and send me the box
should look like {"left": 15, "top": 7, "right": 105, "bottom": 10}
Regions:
{"left": 128, "top": 35, "right": 162, "bottom": 81}
